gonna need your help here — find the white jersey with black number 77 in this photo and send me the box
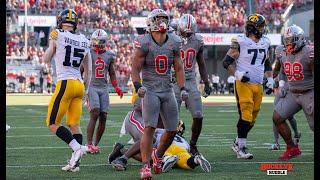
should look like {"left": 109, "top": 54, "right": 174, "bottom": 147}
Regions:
{"left": 232, "top": 35, "right": 270, "bottom": 84}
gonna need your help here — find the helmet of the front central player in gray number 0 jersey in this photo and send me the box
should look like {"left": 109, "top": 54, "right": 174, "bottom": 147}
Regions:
{"left": 146, "top": 9, "right": 170, "bottom": 33}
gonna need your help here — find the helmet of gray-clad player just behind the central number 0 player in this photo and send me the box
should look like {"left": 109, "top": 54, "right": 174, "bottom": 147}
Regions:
{"left": 177, "top": 14, "right": 197, "bottom": 37}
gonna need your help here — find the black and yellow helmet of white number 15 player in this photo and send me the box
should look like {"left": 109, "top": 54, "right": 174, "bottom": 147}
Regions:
{"left": 57, "top": 9, "right": 78, "bottom": 31}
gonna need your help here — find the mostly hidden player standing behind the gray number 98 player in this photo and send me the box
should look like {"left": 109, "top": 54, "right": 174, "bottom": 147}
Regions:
{"left": 269, "top": 45, "right": 301, "bottom": 150}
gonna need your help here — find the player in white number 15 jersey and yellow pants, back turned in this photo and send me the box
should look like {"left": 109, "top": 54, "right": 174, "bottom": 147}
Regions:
{"left": 44, "top": 9, "right": 91, "bottom": 172}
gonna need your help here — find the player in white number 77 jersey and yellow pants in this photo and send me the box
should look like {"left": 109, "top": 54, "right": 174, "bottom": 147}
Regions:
{"left": 223, "top": 14, "right": 274, "bottom": 159}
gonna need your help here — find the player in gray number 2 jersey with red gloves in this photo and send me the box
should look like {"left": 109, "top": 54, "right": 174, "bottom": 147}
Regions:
{"left": 87, "top": 29, "right": 123, "bottom": 153}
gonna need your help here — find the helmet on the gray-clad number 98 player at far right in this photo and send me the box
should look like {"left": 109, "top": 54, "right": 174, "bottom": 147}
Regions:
{"left": 283, "top": 24, "right": 306, "bottom": 54}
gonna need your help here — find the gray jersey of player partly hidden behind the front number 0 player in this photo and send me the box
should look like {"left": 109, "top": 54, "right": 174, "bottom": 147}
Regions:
{"left": 180, "top": 34, "right": 204, "bottom": 79}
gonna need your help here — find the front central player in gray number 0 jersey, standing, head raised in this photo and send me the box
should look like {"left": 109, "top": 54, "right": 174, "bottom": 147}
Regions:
{"left": 132, "top": 9, "right": 188, "bottom": 179}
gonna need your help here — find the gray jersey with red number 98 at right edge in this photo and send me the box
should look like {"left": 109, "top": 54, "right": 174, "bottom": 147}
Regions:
{"left": 280, "top": 46, "right": 314, "bottom": 91}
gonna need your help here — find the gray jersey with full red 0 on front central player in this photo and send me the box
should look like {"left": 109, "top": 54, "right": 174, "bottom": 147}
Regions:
{"left": 135, "top": 33, "right": 181, "bottom": 92}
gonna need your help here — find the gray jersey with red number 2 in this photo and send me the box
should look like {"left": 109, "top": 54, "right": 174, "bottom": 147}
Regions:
{"left": 90, "top": 49, "right": 116, "bottom": 88}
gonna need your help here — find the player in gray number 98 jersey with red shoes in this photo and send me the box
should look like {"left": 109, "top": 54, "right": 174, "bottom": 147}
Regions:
{"left": 273, "top": 25, "right": 314, "bottom": 160}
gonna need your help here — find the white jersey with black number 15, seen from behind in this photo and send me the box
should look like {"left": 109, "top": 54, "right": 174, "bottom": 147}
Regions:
{"left": 49, "top": 29, "right": 90, "bottom": 82}
